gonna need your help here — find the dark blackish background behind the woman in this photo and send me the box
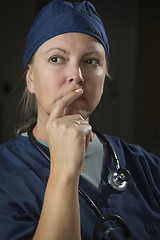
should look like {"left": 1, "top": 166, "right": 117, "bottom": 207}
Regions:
{"left": 0, "top": 0, "right": 160, "bottom": 156}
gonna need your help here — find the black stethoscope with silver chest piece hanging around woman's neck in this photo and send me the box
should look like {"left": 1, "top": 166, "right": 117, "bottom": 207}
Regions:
{"left": 28, "top": 123, "right": 131, "bottom": 240}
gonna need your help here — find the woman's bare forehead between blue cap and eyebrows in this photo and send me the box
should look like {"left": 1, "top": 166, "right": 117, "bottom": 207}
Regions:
{"left": 38, "top": 32, "right": 105, "bottom": 54}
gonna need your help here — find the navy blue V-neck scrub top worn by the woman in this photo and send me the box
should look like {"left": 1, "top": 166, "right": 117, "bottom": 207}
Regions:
{"left": 0, "top": 135, "right": 160, "bottom": 240}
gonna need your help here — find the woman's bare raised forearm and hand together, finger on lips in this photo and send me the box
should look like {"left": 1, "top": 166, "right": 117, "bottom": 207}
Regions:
{"left": 33, "top": 89, "right": 91, "bottom": 240}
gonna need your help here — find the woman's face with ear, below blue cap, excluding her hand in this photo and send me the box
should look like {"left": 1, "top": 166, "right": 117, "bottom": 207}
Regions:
{"left": 26, "top": 33, "right": 106, "bottom": 119}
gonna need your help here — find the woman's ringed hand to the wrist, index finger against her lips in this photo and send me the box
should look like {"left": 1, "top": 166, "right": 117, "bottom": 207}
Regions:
{"left": 46, "top": 89, "right": 92, "bottom": 176}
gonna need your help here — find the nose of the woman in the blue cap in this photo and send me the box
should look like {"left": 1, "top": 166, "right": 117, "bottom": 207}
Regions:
{"left": 66, "top": 66, "right": 84, "bottom": 85}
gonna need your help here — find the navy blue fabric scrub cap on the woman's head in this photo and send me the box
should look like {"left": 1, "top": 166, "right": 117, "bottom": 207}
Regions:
{"left": 23, "top": 0, "right": 109, "bottom": 70}
